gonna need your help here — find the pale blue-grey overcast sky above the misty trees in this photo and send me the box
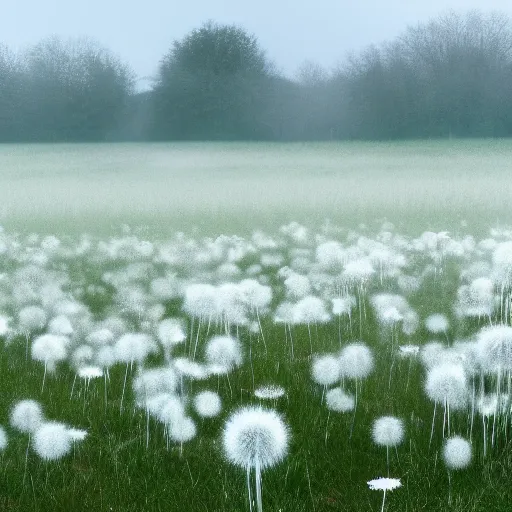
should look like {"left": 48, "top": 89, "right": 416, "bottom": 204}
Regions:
{"left": 0, "top": 0, "right": 512, "bottom": 89}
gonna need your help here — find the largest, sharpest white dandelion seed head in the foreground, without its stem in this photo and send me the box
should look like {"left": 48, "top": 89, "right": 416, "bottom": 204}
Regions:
{"left": 222, "top": 407, "right": 290, "bottom": 469}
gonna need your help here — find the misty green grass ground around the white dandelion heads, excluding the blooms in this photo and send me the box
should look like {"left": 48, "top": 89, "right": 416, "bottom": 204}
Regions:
{"left": 0, "top": 141, "right": 512, "bottom": 512}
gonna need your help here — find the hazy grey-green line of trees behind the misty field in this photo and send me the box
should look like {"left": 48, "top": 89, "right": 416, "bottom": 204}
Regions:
{"left": 0, "top": 11, "right": 512, "bottom": 142}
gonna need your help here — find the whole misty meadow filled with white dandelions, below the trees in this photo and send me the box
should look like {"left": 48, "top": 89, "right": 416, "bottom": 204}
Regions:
{"left": 0, "top": 140, "right": 512, "bottom": 512}
